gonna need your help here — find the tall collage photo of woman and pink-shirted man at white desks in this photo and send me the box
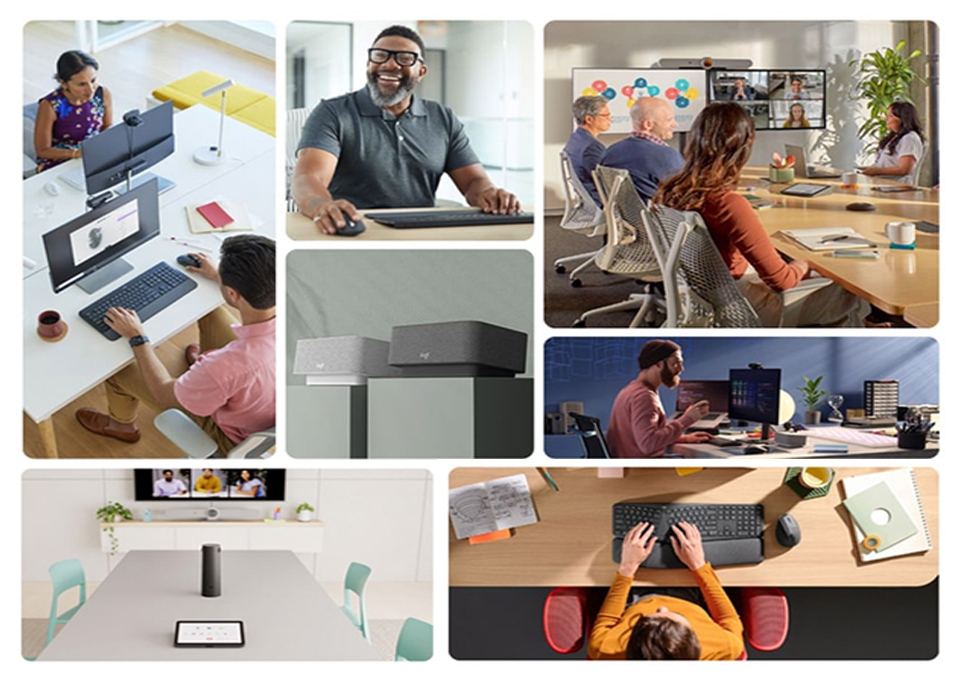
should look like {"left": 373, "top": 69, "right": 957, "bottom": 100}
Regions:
{"left": 22, "top": 21, "right": 276, "bottom": 458}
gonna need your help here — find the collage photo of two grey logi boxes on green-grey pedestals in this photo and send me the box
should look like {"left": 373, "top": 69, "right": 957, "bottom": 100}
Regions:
{"left": 286, "top": 250, "right": 534, "bottom": 459}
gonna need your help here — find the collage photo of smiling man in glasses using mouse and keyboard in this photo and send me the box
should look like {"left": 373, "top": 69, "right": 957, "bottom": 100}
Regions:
{"left": 285, "top": 20, "right": 536, "bottom": 240}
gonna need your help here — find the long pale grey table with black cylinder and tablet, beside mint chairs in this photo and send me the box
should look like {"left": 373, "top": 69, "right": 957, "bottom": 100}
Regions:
{"left": 38, "top": 551, "right": 378, "bottom": 661}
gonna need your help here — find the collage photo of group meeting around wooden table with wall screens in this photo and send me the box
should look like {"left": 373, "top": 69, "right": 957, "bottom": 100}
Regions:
{"left": 543, "top": 21, "right": 940, "bottom": 328}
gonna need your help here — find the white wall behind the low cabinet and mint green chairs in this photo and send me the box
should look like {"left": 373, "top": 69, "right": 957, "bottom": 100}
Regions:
{"left": 22, "top": 468, "right": 433, "bottom": 583}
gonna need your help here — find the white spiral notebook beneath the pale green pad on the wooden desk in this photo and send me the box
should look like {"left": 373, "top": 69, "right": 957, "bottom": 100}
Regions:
{"left": 840, "top": 468, "right": 933, "bottom": 563}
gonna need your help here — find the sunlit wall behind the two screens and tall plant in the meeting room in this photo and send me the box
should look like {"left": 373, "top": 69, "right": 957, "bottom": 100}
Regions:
{"left": 543, "top": 21, "right": 906, "bottom": 210}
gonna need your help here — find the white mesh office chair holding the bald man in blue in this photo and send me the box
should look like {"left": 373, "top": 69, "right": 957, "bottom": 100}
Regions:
{"left": 573, "top": 166, "right": 666, "bottom": 328}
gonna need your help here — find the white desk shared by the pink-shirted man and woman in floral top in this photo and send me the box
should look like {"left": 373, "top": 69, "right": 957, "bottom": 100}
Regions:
{"left": 23, "top": 105, "right": 276, "bottom": 458}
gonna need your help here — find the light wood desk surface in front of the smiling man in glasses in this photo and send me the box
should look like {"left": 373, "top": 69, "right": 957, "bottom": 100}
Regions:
{"left": 287, "top": 207, "right": 535, "bottom": 244}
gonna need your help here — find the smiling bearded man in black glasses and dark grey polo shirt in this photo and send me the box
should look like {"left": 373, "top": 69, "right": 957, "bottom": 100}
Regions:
{"left": 291, "top": 26, "right": 520, "bottom": 235}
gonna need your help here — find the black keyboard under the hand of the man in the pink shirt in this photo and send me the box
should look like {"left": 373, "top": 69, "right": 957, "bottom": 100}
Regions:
{"left": 80, "top": 261, "right": 197, "bottom": 340}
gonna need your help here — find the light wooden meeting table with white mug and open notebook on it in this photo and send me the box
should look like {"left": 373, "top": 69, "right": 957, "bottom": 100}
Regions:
{"left": 738, "top": 167, "right": 940, "bottom": 326}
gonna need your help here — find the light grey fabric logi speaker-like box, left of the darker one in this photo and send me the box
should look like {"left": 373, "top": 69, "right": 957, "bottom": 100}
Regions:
{"left": 293, "top": 336, "right": 400, "bottom": 385}
